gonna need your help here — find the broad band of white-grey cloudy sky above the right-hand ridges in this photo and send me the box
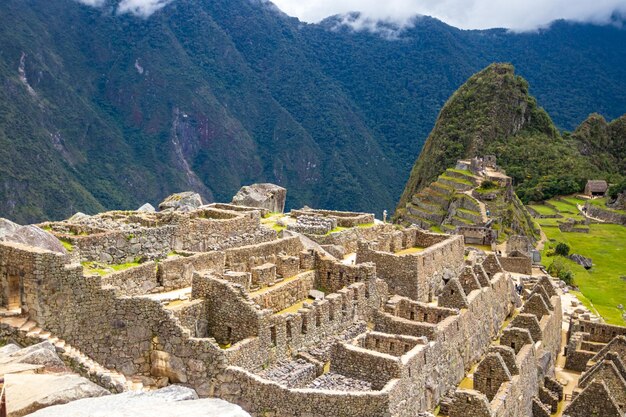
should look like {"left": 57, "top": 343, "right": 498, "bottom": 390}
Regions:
{"left": 272, "top": 0, "right": 626, "bottom": 31}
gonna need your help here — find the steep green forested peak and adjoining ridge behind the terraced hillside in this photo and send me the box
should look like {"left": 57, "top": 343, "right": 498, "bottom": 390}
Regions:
{"left": 398, "top": 64, "right": 626, "bottom": 208}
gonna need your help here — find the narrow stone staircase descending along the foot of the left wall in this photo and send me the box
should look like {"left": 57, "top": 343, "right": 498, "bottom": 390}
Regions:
{"left": 0, "top": 316, "right": 147, "bottom": 393}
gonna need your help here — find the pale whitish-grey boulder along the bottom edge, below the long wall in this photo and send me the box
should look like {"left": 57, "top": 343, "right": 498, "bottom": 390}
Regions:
{"left": 30, "top": 385, "right": 250, "bottom": 417}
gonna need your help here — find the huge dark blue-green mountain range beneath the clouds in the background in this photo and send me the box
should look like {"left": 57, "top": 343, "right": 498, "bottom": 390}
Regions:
{"left": 0, "top": 0, "right": 626, "bottom": 222}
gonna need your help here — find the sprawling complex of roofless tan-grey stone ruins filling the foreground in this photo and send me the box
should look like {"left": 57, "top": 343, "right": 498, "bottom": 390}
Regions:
{"left": 0, "top": 188, "right": 623, "bottom": 417}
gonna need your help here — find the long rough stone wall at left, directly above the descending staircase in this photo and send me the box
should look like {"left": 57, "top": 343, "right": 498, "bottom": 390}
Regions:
{"left": 0, "top": 240, "right": 226, "bottom": 395}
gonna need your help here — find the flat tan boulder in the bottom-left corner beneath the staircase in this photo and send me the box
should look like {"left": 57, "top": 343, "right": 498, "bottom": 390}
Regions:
{"left": 4, "top": 374, "right": 110, "bottom": 417}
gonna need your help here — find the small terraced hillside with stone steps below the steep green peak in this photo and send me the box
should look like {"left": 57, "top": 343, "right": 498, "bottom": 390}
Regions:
{"left": 399, "top": 165, "right": 539, "bottom": 241}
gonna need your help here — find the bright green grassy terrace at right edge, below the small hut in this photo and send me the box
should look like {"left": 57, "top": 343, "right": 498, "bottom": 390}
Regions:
{"left": 536, "top": 197, "right": 626, "bottom": 325}
